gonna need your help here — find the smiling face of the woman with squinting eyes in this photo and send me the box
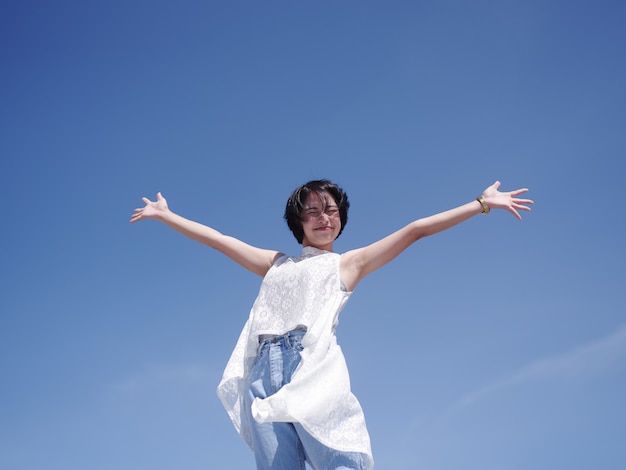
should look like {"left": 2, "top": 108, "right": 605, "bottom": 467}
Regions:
{"left": 300, "top": 193, "right": 341, "bottom": 251}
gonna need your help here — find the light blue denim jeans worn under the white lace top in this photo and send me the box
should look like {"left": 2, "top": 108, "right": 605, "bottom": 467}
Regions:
{"left": 244, "top": 330, "right": 363, "bottom": 470}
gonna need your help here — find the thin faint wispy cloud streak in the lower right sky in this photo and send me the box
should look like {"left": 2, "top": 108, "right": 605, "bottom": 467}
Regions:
{"left": 445, "top": 325, "right": 626, "bottom": 417}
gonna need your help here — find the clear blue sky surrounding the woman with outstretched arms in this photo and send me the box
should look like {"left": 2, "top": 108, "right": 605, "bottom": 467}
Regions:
{"left": 0, "top": 0, "right": 626, "bottom": 470}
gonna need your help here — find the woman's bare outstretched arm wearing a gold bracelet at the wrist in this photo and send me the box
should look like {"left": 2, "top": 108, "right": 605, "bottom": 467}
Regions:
{"left": 341, "top": 181, "right": 533, "bottom": 290}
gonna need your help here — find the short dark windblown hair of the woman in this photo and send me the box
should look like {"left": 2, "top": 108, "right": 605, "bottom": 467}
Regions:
{"left": 285, "top": 180, "right": 350, "bottom": 244}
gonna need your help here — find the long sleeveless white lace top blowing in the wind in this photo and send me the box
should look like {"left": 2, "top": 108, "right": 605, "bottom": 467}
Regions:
{"left": 217, "top": 247, "right": 373, "bottom": 468}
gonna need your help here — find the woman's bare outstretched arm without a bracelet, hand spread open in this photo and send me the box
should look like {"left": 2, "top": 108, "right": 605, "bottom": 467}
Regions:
{"left": 130, "top": 193, "right": 280, "bottom": 276}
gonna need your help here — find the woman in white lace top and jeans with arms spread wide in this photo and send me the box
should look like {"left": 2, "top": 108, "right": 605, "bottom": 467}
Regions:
{"left": 130, "top": 180, "right": 533, "bottom": 470}
